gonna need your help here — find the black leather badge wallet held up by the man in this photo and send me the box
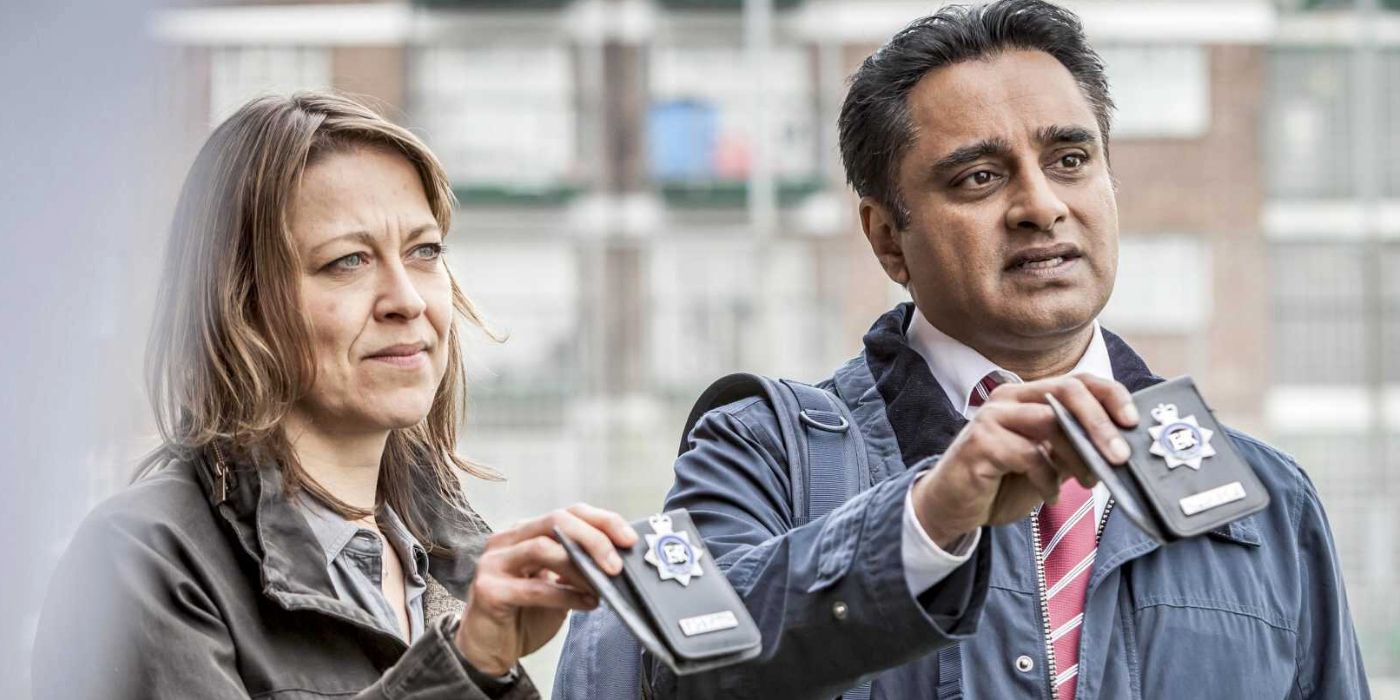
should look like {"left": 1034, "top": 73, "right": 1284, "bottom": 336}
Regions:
{"left": 1047, "top": 377, "right": 1268, "bottom": 543}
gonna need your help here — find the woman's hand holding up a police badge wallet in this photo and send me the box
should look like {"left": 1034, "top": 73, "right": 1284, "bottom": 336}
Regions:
{"left": 456, "top": 504, "right": 637, "bottom": 676}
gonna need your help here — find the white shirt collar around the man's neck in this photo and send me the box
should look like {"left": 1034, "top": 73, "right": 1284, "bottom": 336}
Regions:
{"left": 906, "top": 307, "right": 1113, "bottom": 417}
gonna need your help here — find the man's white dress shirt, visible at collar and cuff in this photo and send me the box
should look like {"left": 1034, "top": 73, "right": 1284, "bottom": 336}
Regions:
{"left": 900, "top": 308, "right": 1113, "bottom": 596}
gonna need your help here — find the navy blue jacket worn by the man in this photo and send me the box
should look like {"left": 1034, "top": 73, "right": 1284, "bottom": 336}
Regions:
{"left": 556, "top": 304, "right": 1369, "bottom": 700}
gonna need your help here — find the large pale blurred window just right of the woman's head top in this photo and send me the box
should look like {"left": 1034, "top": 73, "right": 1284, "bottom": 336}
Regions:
{"left": 412, "top": 46, "right": 577, "bottom": 193}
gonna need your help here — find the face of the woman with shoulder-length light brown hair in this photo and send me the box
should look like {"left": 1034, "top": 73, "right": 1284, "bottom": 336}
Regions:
{"left": 288, "top": 147, "right": 452, "bottom": 434}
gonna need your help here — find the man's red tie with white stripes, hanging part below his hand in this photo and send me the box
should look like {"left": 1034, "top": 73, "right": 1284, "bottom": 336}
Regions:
{"left": 1039, "top": 479, "right": 1098, "bottom": 700}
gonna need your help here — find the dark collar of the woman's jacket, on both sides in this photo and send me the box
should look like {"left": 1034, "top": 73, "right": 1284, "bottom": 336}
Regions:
{"left": 193, "top": 451, "right": 490, "bottom": 613}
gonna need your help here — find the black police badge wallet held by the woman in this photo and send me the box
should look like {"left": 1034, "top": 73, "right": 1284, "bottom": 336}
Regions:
{"left": 554, "top": 508, "right": 763, "bottom": 675}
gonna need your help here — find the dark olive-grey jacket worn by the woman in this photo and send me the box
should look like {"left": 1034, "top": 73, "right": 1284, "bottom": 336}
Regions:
{"left": 32, "top": 450, "right": 538, "bottom": 700}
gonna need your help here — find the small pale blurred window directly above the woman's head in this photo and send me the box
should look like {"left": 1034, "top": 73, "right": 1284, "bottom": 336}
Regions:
{"left": 209, "top": 46, "right": 330, "bottom": 125}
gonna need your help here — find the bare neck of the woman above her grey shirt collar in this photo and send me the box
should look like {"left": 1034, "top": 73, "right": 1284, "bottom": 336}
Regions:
{"left": 284, "top": 410, "right": 389, "bottom": 510}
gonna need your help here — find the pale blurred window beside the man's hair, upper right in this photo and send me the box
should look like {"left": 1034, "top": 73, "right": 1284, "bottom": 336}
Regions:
{"left": 1099, "top": 46, "right": 1211, "bottom": 139}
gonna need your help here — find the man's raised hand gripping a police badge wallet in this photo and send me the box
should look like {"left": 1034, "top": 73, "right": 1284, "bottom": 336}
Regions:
{"left": 914, "top": 374, "right": 1138, "bottom": 550}
